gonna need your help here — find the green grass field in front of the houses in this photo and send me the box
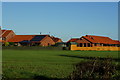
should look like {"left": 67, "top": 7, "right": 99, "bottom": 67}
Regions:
{"left": 2, "top": 49, "right": 118, "bottom": 79}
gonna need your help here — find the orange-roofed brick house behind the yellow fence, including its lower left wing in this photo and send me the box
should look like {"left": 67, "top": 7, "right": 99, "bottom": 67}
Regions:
{"left": 68, "top": 35, "right": 120, "bottom": 47}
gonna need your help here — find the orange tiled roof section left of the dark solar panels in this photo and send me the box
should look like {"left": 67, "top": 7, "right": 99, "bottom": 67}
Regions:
{"left": 8, "top": 35, "right": 35, "bottom": 42}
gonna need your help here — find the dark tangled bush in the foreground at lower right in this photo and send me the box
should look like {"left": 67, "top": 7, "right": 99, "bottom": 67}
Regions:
{"left": 69, "top": 58, "right": 120, "bottom": 80}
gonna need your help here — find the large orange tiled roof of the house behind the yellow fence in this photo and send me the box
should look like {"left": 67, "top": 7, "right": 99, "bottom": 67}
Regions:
{"left": 82, "top": 35, "right": 118, "bottom": 44}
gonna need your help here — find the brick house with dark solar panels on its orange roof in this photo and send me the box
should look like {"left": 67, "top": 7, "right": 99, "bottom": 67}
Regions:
{"left": 8, "top": 35, "right": 55, "bottom": 46}
